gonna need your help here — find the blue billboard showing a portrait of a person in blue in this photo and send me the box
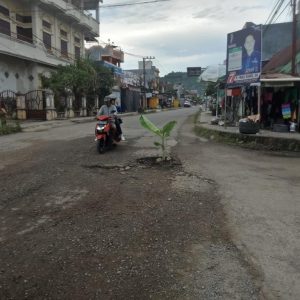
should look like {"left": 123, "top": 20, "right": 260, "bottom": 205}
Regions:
{"left": 226, "top": 25, "right": 262, "bottom": 88}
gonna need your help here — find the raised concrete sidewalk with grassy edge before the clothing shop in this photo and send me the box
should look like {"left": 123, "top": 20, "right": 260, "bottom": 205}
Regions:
{"left": 196, "top": 111, "right": 300, "bottom": 152}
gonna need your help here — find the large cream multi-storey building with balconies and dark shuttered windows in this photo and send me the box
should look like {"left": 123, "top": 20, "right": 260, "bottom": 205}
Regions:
{"left": 0, "top": 0, "right": 102, "bottom": 94}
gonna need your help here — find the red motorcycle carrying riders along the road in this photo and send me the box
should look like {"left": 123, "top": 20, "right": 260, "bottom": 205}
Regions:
{"left": 95, "top": 115, "right": 121, "bottom": 154}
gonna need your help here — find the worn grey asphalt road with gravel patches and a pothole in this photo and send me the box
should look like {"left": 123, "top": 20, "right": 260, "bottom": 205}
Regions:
{"left": 0, "top": 108, "right": 300, "bottom": 299}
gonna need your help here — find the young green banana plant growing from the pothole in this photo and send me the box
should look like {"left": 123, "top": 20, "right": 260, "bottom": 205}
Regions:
{"left": 140, "top": 115, "right": 177, "bottom": 161}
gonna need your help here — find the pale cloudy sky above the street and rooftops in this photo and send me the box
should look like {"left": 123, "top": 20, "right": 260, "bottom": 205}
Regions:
{"left": 100, "top": 0, "right": 291, "bottom": 76}
